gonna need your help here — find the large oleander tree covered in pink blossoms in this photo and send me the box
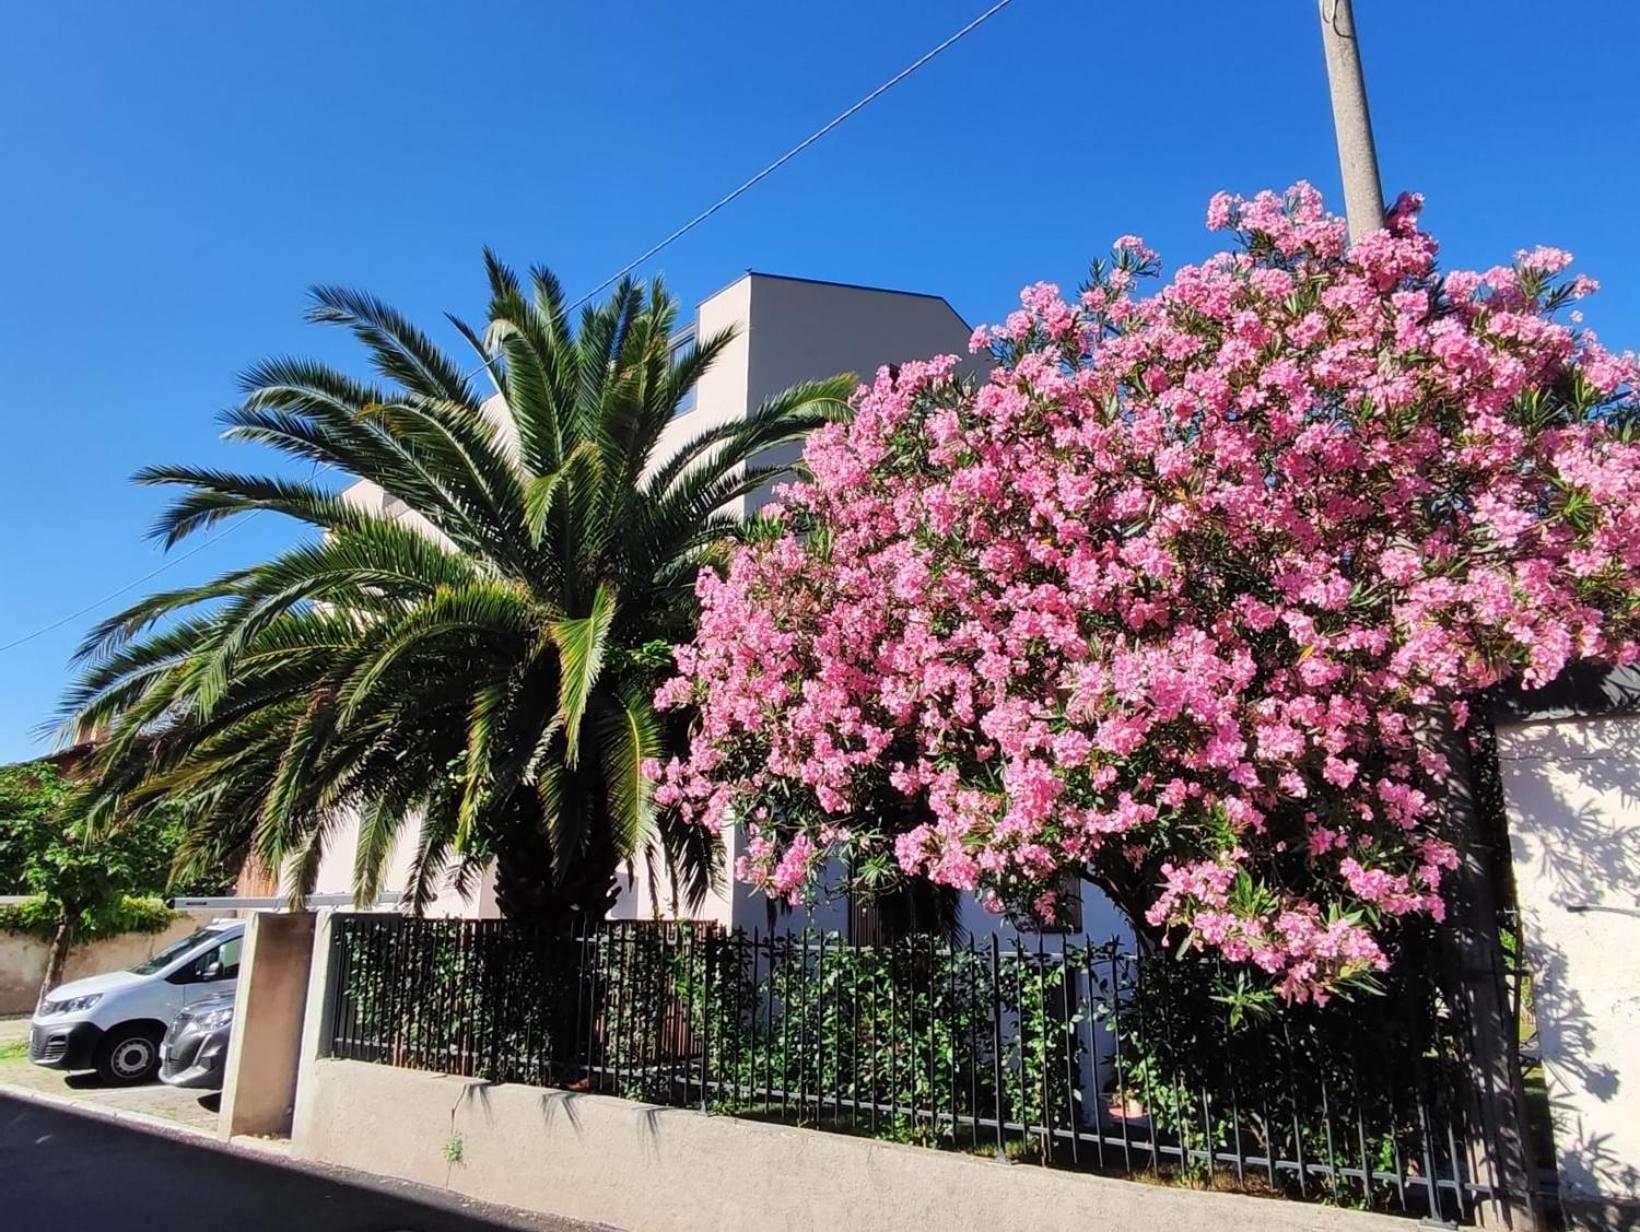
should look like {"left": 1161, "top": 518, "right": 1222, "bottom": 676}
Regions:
{"left": 651, "top": 184, "right": 1640, "bottom": 999}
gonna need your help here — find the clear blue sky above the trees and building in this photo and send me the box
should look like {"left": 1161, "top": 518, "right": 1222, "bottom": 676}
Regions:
{"left": 0, "top": 0, "right": 1640, "bottom": 760}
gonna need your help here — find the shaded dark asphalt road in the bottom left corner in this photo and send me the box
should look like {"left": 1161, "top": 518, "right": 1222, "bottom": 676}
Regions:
{"left": 0, "top": 1094, "right": 595, "bottom": 1232}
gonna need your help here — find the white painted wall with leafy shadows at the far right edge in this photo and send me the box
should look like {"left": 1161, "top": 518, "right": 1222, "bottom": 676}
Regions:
{"left": 1497, "top": 715, "right": 1640, "bottom": 1219}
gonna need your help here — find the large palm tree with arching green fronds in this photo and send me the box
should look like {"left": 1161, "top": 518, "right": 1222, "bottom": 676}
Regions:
{"left": 67, "top": 253, "right": 848, "bottom": 924}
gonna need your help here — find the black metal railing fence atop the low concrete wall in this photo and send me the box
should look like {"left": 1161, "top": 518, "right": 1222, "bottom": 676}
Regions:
{"left": 319, "top": 914, "right": 1491, "bottom": 1222}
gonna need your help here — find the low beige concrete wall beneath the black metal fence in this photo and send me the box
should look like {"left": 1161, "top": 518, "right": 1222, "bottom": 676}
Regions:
{"left": 292, "top": 1060, "right": 1414, "bottom": 1232}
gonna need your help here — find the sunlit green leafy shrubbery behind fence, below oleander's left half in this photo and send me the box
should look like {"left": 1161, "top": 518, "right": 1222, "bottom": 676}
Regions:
{"left": 685, "top": 933, "right": 1081, "bottom": 1150}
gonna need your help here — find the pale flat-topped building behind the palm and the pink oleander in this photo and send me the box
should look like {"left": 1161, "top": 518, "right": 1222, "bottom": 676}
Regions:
{"left": 305, "top": 272, "right": 1127, "bottom": 937}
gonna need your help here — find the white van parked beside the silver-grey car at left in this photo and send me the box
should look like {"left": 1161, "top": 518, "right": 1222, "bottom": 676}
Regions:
{"left": 28, "top": 920, "right": 244, "bottom": 1086}
